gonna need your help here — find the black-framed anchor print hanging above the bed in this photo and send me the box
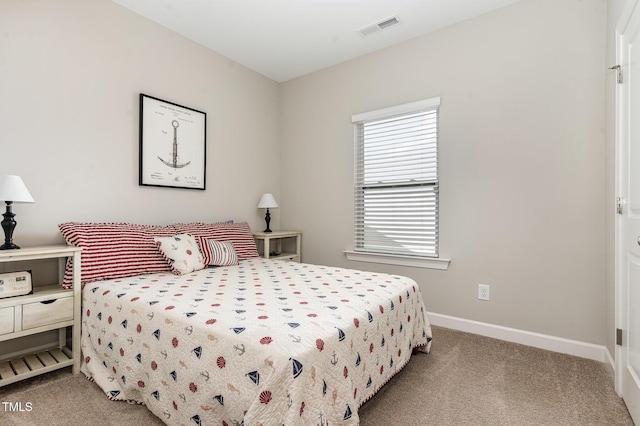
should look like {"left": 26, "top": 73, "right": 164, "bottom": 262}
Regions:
{"left": 139, "top": 93, "right": 207, "bottom": 190}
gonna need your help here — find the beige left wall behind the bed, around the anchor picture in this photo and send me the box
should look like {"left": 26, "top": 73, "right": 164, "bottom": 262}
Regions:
{"left": 0, "top": 0, "right": 280, "bottom": 246}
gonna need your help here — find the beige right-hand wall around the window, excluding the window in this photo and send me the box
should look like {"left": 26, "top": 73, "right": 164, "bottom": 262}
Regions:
{"left": 280, "top": 0, "right": 608, "bottom": 344}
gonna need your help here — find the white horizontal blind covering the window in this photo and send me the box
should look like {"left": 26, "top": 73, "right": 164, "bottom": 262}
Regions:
{"left": 352, "top": 98, "right": 440, "bottom": 257}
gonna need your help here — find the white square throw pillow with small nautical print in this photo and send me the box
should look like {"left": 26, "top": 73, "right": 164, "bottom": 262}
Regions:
{"left": 153, "top": 234, "right": 206, "bottom": 275}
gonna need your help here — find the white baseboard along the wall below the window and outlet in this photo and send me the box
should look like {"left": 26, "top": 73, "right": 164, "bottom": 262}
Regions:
{"left": 427, "top": 312, "right": 615, "bottom": 371}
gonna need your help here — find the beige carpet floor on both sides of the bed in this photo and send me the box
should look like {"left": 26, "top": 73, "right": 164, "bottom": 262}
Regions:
{"left": 0, "top": 327, "right": 633, "bottom": 426}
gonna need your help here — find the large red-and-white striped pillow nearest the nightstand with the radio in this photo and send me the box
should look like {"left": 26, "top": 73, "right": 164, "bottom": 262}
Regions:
{"left": 58, "top": 222, "right": 176, "bottom": 288}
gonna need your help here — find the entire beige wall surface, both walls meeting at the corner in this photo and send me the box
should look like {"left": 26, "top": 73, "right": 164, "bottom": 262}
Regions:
{"left": 0, "top": 0, "right": 612, "bottom": 350}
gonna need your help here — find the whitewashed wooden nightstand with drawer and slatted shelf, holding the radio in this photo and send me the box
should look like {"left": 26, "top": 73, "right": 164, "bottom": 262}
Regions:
{"left": 0, "top": 245, "right": 82, "bottom": 387}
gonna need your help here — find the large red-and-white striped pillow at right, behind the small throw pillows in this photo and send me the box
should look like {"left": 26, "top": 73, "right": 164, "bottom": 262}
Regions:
{"left": 173, "top": 222, "right": 259, "bottom": 265}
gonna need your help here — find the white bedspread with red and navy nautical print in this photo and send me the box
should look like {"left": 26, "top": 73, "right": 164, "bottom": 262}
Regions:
{"left": 82, "top": 258, "right": 431, "bottom": 426}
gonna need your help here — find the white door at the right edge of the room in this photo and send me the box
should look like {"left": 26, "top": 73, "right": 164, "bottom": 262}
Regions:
{"left": 616, "top": 0, "right": 640, "bottom": 425}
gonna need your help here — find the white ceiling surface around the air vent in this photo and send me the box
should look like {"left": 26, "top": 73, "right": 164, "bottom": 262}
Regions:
{"left": 113, "top": 0, "right": 520, "bottom": 82}
